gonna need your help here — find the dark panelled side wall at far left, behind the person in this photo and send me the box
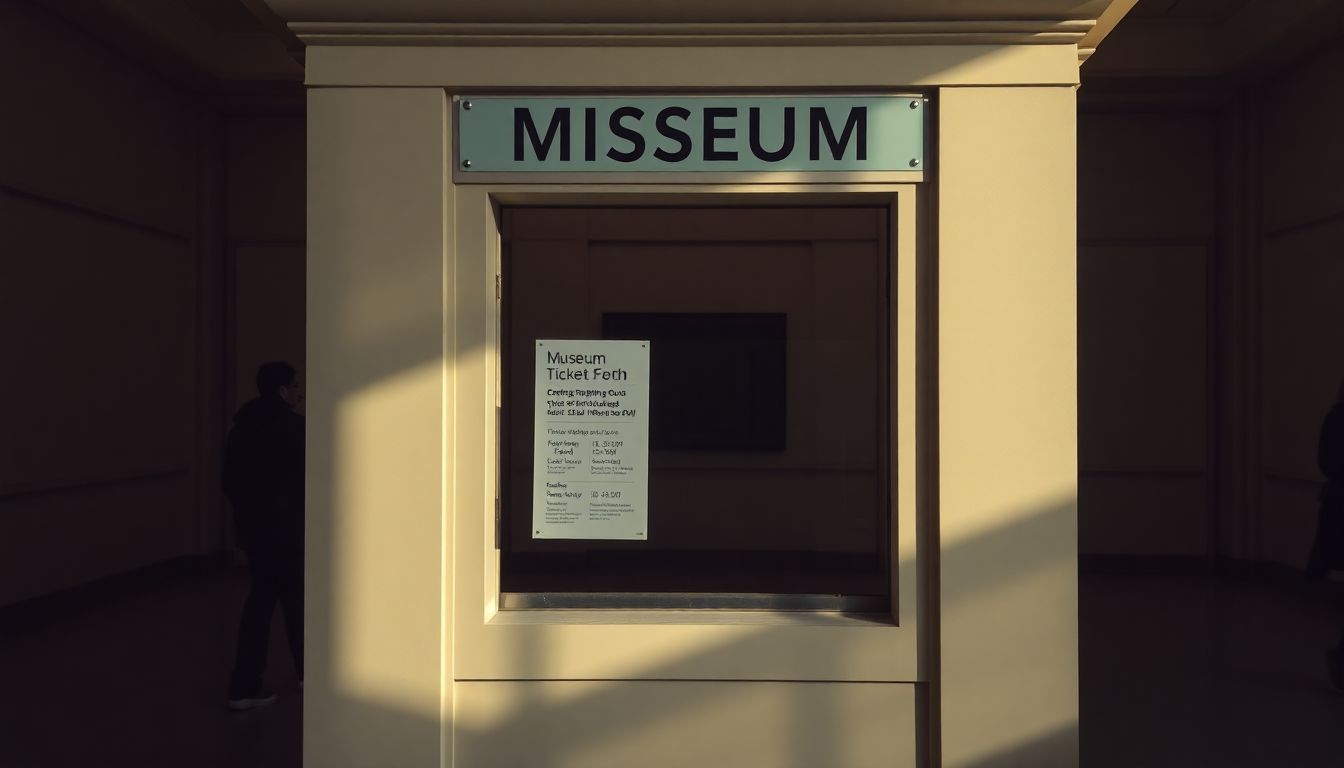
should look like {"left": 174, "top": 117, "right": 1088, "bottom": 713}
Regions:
{"left": 0, "top": 3, "right": 220, "bottom": 605}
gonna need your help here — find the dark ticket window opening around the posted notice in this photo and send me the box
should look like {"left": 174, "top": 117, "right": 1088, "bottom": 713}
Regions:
{"left": 499, "top": 207, "right": 892, "bottom": 613}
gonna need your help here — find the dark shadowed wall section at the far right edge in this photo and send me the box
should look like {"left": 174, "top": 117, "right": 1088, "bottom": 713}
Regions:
{"left": 1255, "top": 42, "right": 1344, "bottom": 568}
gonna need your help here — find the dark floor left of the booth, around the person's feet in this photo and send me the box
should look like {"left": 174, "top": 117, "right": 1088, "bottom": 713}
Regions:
{"left": 0, "top": 569, "right": 302, "bottom": 768}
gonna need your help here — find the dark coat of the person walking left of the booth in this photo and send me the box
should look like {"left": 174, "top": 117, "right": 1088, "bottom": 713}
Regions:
{"left": 223, "top": 395, "right": 304, "bottom": 551}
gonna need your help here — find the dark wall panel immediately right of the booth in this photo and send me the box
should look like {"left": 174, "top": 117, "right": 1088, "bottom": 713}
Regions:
{"left": 1078, "top": 109, "right": 1218, "bottom": 555}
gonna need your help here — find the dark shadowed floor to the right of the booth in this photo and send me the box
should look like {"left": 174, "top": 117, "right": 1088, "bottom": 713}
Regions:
{"left": 1079, "top": 576, "right": 1344, "bottom": 768}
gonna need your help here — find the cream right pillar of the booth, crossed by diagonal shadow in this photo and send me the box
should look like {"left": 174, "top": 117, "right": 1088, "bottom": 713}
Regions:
{"left": 935, "top": 87, "right": 1078, "bottom": 768}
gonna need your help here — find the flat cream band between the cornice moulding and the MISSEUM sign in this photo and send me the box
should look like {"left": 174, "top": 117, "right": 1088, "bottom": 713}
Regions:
{"left": 306, "top": 44, "right": 1078, "bottom": 93}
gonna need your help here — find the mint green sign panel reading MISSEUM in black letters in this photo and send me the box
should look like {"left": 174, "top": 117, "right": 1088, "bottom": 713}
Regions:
{"left": 457, "top": 95, "right": 926, "bottom": 174}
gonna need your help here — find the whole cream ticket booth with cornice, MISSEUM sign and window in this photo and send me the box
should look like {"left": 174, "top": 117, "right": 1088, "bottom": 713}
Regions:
{"left": 271, "top": 0, "right": 1129, "bottom": 768}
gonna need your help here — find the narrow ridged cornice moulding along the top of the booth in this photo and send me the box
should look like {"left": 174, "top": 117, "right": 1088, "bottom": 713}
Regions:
{"left": 289, "top": 19, "right": 1097, "bottom": 47}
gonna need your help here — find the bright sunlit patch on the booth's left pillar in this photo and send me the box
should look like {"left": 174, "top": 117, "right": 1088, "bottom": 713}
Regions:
{"left": 325, "top": 360, "right": 442, "bottom": 718}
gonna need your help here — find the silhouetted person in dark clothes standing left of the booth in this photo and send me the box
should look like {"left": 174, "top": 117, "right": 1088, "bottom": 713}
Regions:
{"left": 224, "top": 362, "right": 304, "bottom": 710}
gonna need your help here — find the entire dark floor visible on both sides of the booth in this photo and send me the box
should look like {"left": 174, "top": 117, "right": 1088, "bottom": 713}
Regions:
{"left": 0, "top": 562, "right": 1344, "bottom": 768}
